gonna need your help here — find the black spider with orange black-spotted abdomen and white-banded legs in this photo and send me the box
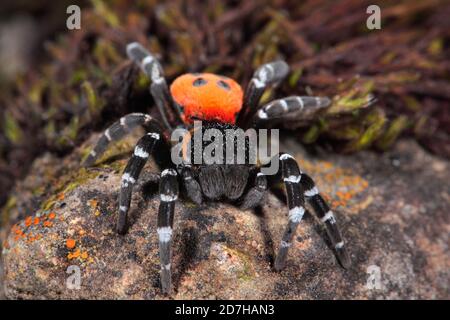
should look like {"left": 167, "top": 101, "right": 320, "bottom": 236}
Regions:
{"left": 84, "top": 42, "right": 350, "bottom": 294}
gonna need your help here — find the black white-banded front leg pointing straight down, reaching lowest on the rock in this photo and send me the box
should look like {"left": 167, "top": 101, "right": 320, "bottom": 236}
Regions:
{"left": 157, "top": 169, "right": 178, "bottom": 294}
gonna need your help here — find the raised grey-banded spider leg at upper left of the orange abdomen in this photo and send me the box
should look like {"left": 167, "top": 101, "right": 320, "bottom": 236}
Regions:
{"left": 127, "top": 42, "right": 181, "bottom": 130}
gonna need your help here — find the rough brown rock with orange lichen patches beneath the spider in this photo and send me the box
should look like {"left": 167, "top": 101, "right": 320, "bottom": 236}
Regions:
{"left": 2, "top": 136, "right": 450, "bottom": 299}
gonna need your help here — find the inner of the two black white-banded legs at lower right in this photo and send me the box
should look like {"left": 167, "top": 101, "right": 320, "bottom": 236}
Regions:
{"left": 274, "top": 153, "right": 305, "bottom": 271}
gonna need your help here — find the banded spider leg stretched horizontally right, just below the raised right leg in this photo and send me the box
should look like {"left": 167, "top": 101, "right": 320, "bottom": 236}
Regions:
{"left": 254, "top": 96, "right": 331, "bottom": 122}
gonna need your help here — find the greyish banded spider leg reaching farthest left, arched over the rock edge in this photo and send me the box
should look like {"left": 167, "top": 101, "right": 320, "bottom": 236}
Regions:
{"left": 83, "top": 113, "right": 158, "bottom": 166}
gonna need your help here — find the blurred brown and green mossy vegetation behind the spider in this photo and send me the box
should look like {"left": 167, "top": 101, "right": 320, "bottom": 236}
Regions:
{"left": 0, "top": 0, "right": 450, "bottom": 210}
